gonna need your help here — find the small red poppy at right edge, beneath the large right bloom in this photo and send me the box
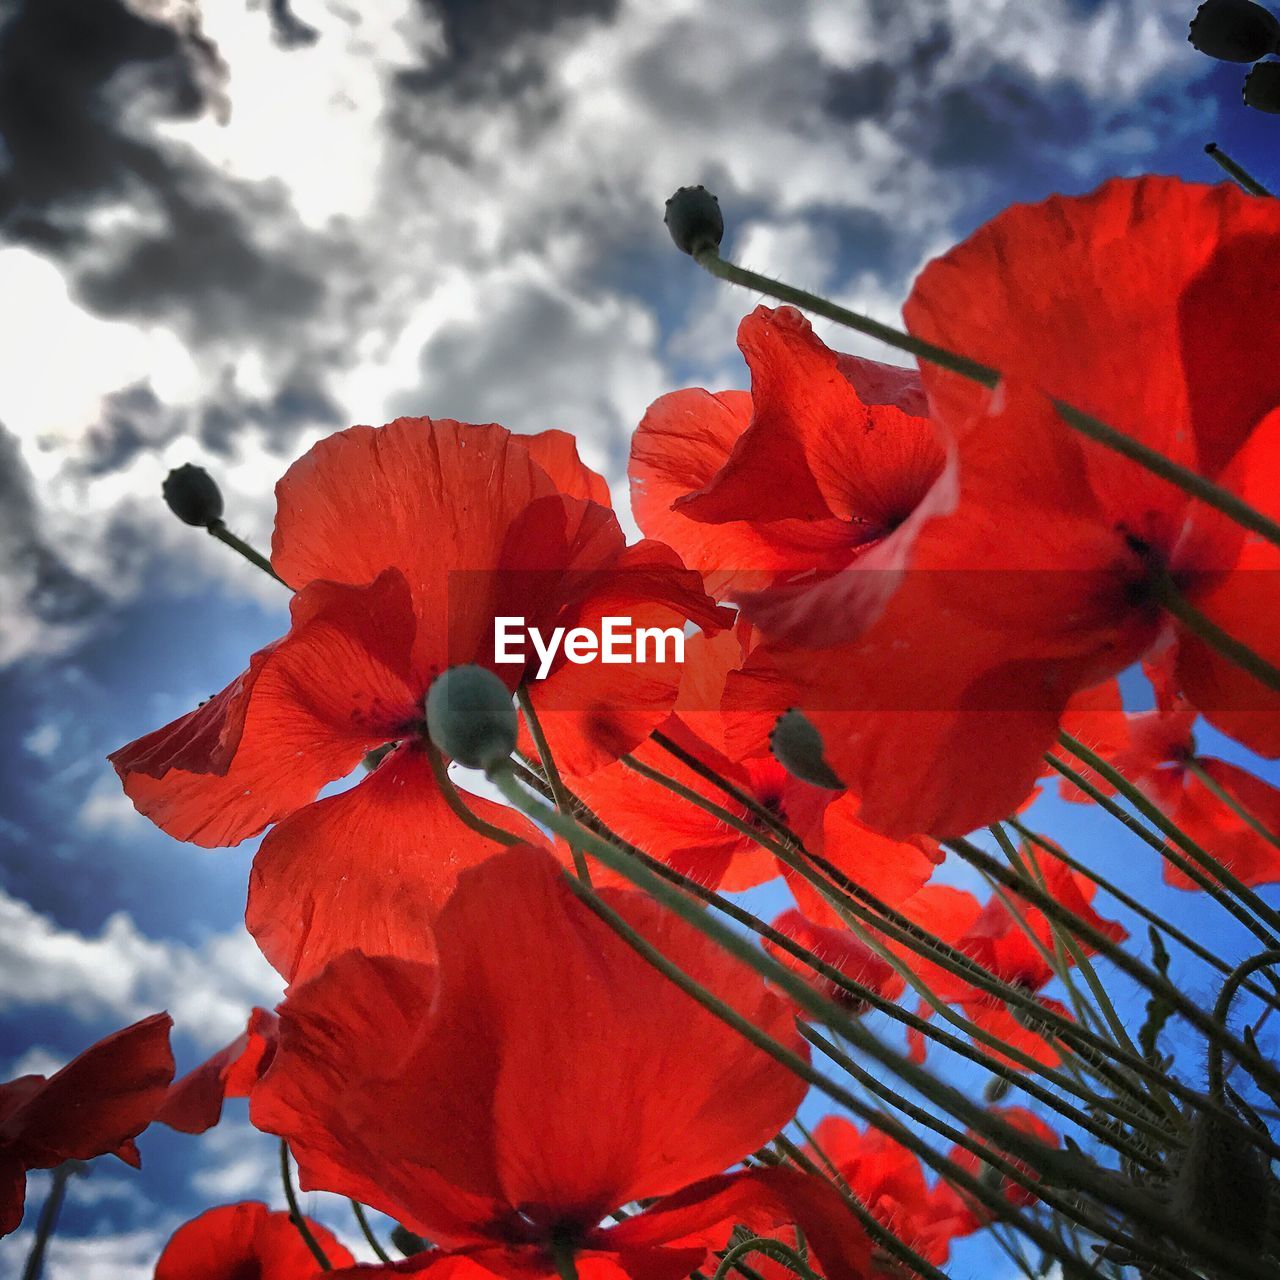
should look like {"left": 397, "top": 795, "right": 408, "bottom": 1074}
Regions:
{"left": 1061, "top": 649, "right": 1280, "bottom": 888}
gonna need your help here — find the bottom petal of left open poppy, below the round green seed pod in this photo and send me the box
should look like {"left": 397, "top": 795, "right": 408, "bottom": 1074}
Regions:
{"left": 244, "top": 744, "right": 539, "bottom": 982}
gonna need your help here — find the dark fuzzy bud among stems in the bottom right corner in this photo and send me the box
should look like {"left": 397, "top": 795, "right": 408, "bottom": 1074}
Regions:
{"left": 1172, "top": 1111, "right": 1271, "bottom": 1248}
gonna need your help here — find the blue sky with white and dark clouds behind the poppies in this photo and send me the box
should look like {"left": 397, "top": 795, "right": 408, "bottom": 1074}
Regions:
{"left": 0, "top": 0, "right": 1280, "bottom": 1280}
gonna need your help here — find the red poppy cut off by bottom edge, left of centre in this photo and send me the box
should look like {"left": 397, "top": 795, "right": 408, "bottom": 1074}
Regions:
{"left": 155, "top": 1201, "right": 356, "bottom": 1280}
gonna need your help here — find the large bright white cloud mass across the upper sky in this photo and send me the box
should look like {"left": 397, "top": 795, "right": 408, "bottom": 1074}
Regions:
{"left": 0, "top": 0, "right": 1197, "bottom": 663}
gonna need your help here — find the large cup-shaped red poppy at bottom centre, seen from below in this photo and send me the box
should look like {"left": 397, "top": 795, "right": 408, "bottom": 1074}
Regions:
{"left": 250, "top": 847, "right": 865, "bottom": 1280}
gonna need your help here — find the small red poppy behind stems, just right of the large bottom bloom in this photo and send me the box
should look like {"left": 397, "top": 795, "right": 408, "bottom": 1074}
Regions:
{"left": 809, "top": 1116, "right": 977, "bottom": 1280}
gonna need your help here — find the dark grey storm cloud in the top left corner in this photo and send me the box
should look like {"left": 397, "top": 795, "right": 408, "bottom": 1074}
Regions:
{"left": 0, "top": 0, "right": 328, "bottom": 340}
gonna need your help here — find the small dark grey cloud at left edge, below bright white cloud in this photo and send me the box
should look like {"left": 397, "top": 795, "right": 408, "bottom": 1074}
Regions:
{"left": 0, "top": 424, "right": 102, "bottom": 626}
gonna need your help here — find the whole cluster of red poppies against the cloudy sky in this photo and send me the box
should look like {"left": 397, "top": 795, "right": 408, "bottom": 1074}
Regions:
{"left": 10, "top": 178, "right": 1280, "bottom": 1280}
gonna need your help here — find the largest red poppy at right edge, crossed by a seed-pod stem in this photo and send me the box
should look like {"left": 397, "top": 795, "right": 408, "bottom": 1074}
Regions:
{"left": 746, "top": 178, "right": 1280, "bottom": 836}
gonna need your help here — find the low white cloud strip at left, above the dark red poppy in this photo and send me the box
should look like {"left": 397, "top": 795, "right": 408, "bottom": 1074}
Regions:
{"left": 0, "top": 892, "right": 282, "bottom": 1048}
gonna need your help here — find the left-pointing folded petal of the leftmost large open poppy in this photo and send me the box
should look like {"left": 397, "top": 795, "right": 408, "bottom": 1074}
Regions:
{"left": 110, "top": 572, "right": 420, "bottom": 847}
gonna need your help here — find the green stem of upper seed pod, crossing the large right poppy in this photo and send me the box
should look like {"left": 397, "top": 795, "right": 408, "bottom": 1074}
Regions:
{"left": 694, "top": 246, "right": 1280, "bottom": 547}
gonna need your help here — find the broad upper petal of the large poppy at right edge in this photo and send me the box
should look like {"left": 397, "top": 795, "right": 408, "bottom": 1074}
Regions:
{"left": 904, "top": 178, "right": 1280, "bottom": 488}
